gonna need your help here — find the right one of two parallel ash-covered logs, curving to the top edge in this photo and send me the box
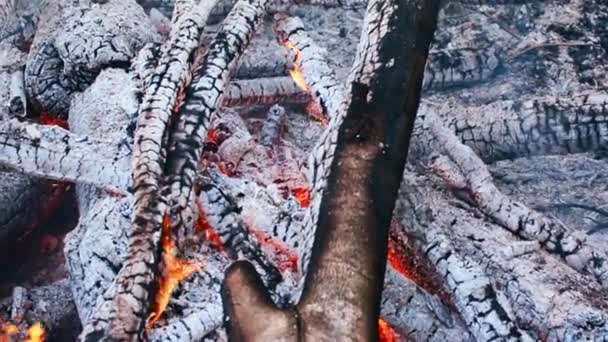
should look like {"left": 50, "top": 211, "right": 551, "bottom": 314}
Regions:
{"left": 166, "top": 0, "right": 269, "bottom": 254}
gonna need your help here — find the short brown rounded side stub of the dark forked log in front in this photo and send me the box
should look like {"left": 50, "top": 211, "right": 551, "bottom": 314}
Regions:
{"left": 222, "top": 261, "right": 299, "bottom": 341}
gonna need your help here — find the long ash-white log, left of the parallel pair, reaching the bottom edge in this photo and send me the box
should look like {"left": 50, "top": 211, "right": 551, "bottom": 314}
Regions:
{"left": 81, "top": 1, "right": 221, "bottom": 340}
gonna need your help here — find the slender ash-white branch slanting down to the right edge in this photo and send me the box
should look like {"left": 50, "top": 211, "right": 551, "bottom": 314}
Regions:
{"left": 421, "top": 113, "right": 608, "bottom": 287}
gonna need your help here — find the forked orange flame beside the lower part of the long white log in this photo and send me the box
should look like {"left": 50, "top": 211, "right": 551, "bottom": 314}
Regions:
{"left": 148, "top": 216, "right": 202, "bottom": 329}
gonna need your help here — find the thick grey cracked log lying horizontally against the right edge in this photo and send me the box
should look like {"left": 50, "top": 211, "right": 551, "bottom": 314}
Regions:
{"left": 416, "top": 91, "right": 608, "bottom": 162}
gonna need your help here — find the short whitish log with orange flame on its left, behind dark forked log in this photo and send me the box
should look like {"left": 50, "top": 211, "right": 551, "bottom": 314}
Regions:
{"left": 274, "top": 14, "right": 345, "bottom": 122}
